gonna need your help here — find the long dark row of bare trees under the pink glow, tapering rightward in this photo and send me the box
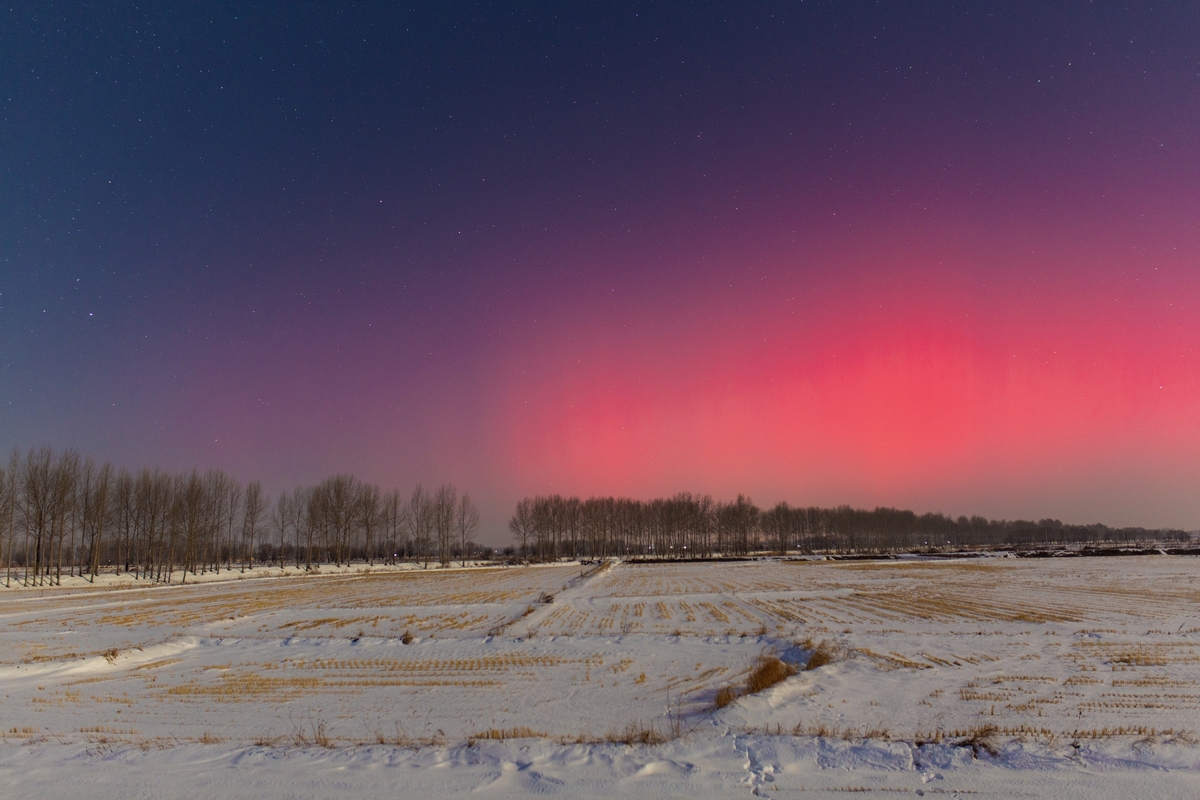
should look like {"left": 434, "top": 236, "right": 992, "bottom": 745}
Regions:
{"left": 509, "top": 494, "right": 1190, "bottom": 560}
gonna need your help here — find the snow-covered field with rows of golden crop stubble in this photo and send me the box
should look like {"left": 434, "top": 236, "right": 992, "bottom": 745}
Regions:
{"left": 0, "top": 557, "right": 1200, "bottom": 798}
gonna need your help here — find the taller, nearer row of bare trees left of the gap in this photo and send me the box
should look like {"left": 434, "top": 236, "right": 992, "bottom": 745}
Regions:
{"left": 0, "top": 447, "right": 479, "bottom": 587}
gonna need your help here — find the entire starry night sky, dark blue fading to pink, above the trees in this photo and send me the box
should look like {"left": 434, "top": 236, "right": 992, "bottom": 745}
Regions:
{"left": 0, "top": 1, "right": 1200, "bottom": 542}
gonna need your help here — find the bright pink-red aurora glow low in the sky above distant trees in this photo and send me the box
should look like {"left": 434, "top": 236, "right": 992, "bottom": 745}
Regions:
{"left": 496, "top": 224, "right": 1200, "bottom": 524}
